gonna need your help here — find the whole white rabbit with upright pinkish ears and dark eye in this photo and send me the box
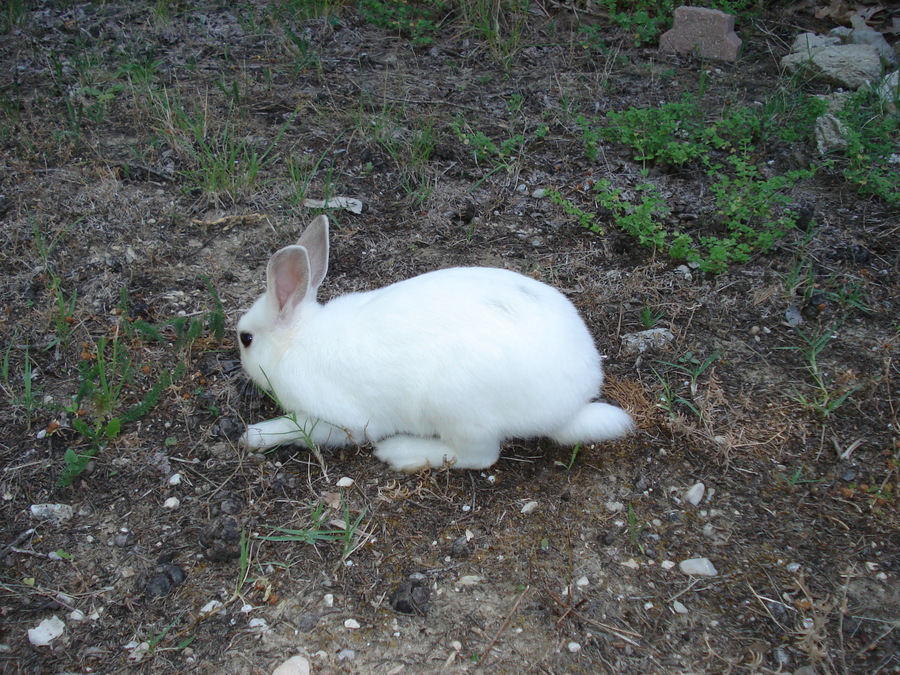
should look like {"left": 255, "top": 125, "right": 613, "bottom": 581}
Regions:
{"left": 237, "top": 216, "right": 633, "bottom": 471}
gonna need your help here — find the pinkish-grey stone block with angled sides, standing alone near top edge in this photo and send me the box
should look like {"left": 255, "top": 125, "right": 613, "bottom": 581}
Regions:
{"left": 659, "top": 6, "right": 741, "bottom": 61}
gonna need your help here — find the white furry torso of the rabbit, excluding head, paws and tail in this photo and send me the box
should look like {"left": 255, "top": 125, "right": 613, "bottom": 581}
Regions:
{"left": 272, "top": 268, "right": 603, "bottom": 441}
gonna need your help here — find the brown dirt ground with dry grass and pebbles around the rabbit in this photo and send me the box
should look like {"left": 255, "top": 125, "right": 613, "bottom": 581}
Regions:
{"left": 0, "top": 2, "right": 900, "bottom": 675}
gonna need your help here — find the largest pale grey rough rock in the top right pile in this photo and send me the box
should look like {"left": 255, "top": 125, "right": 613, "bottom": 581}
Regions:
{"left": 781, "top": 33, "right": 881, "bottom": 89}
